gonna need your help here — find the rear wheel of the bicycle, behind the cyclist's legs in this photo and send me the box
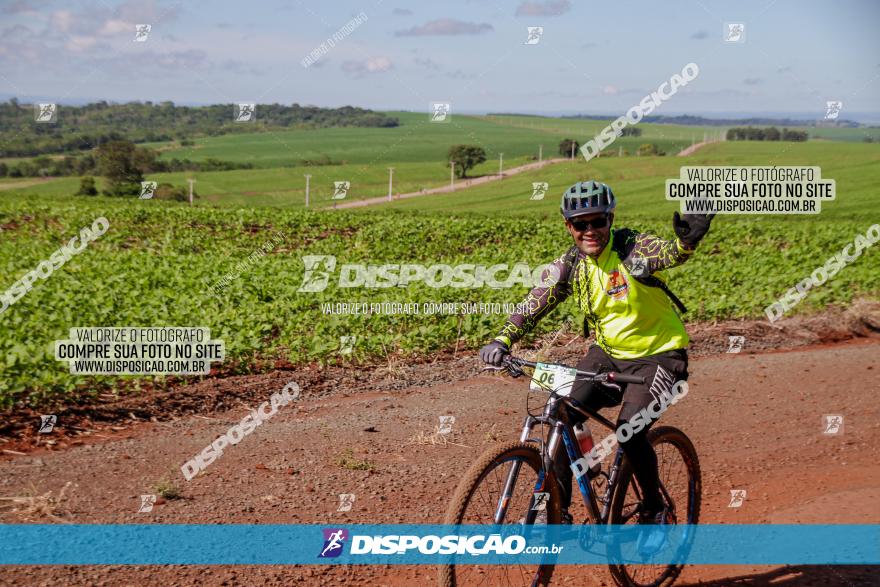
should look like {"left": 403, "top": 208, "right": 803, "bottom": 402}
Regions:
{"left": 608, "top": 426, "right": 702, "bottom": 587}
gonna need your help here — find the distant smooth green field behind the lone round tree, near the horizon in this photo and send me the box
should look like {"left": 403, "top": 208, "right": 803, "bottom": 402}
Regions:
{"left": 147, "top": 112, "right": 724, "bottom": 171}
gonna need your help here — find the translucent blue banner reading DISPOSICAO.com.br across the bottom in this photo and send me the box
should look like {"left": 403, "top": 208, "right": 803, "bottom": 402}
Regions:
{"left": 0, "top": 524, "right": 880, "bottom": 565}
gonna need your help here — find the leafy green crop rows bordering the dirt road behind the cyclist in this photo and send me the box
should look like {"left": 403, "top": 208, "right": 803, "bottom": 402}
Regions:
{"left": 0, "top": 195, "right": 880, "bottom": 407}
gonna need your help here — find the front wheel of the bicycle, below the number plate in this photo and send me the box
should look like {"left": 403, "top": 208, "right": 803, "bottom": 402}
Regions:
{"left": 439, "top": 442, "right": 561, "bottom": 587}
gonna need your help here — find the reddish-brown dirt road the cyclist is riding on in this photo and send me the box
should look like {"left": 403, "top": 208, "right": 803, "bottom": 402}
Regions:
{"left": 0, "top": 330, "right": 880, "bottom": 586}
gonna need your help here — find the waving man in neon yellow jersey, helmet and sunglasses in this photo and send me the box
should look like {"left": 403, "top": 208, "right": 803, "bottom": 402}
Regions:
{"left": 480, "top": 180, "right": 714, "bottom": 524}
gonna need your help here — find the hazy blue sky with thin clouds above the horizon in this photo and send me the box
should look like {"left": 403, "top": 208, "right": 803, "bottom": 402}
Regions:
{"left": 0, "top": 0, "right": 880, "bottom": 120}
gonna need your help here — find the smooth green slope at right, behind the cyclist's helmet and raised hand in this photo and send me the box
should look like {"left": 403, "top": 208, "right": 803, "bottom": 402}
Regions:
{"left": 382, "top": 141, "right": 880, "bottom": 220}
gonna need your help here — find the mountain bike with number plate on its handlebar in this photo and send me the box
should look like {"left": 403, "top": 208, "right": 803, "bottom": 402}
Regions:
{"left": 439, "top": 356, "right": 701, "bottom": 587}
